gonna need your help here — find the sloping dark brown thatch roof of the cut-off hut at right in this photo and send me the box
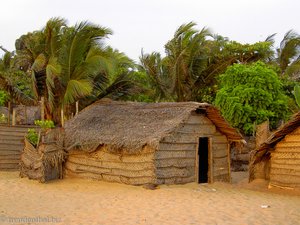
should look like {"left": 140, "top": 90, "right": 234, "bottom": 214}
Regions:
{"left": 250, "top": 111, "right": 300, "bottom": 178}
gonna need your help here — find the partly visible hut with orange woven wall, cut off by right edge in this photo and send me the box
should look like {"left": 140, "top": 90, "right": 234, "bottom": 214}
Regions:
{"left": 249, "top": 112, "right": 300, "bottom": 188}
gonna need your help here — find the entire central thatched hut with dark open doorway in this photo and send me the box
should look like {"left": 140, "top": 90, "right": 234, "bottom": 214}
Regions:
{"left": 65, "top": 100, "right": 243, "bottom": 185}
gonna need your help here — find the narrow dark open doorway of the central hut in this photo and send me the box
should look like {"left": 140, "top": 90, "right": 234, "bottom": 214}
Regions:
{"left": 198, "top": 137, "right": 209, "bottom": 183}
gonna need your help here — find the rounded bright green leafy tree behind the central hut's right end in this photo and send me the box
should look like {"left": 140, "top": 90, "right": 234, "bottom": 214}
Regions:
{"left": 215, "top": 62, "right": 288, "bottom": 134}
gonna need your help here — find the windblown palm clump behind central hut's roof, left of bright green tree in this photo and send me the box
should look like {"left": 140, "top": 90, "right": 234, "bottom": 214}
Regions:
{"left": 140, "top": 22, "right": 273, "bottom": 102}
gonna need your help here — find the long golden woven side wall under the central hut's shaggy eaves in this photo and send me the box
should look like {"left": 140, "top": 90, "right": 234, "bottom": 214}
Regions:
{"left": 65, "top": 147, "right": 156, "bottom": 185}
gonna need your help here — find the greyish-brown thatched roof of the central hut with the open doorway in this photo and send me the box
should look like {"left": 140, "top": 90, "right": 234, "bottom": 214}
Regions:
{"left": 65, "top": 100, "right": 243, "bottom": 154}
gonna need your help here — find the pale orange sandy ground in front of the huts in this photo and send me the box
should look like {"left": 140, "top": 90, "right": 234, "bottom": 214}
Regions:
{"left": 0, "top": 172, "right": 300, "bottom": 225}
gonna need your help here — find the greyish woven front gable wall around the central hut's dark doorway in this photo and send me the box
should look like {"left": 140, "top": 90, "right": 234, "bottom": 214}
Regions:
{"left": 155, "top": 114, "right": 229, "bottom": 184}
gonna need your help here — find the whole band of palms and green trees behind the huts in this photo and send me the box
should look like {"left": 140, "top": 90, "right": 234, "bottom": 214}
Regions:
{"left": 0, "top": 18, "right": 300, "bottom": 134}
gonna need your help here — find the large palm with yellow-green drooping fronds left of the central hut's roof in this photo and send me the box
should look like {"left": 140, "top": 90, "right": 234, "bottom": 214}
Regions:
{"left": 12, "top": 18, "right": 112, "bottom": 122}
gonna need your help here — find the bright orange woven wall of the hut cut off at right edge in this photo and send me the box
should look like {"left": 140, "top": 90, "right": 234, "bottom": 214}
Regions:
{"left": 270, "top": 127, "right": 300, "bottom": 188}
